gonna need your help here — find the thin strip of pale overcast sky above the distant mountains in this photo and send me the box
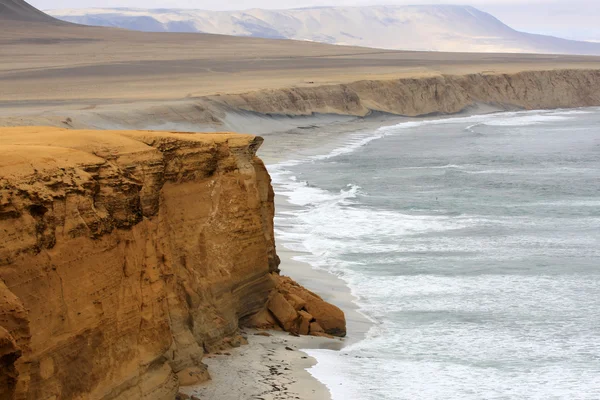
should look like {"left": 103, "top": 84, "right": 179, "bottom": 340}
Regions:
{"left": 28, "top": 0, "right": 600, "bottom": 41}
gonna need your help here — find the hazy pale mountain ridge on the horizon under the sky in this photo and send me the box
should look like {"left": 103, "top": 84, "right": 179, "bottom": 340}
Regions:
{"left": 49, "top": 5, "right": 600, "bottom": 55}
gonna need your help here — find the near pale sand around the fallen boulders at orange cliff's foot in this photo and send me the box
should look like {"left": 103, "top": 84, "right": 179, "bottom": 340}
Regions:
{"left": 181, "top": 231, "right": 371, "bottom": 400}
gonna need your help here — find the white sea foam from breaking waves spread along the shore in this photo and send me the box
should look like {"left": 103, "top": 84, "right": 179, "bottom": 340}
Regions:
{"left": 269, "top": 110, "right": 600, "bottom": 400}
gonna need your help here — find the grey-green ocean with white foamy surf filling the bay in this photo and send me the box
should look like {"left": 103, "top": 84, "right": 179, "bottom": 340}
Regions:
{"left": 269, "top": 108, "right": 600, "bottom": 400}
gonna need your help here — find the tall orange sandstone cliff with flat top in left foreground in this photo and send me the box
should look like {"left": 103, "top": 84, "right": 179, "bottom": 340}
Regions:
{"left": 0, "top": 127, "right": 341, "bottom": 400}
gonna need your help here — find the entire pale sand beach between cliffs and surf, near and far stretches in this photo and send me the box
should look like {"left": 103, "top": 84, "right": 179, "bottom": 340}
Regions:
{"left": 176, "top": 116, "right": 386, "bottom": 400}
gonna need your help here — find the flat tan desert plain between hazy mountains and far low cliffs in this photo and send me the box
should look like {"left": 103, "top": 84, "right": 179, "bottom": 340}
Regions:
{"left": 0, "top": 3, "right": 600, "bottom": 131}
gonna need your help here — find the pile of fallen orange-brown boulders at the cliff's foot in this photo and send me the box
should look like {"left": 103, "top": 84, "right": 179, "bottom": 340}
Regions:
{"left": 245, "top": 274, "right": 346, "bottom": 337}
